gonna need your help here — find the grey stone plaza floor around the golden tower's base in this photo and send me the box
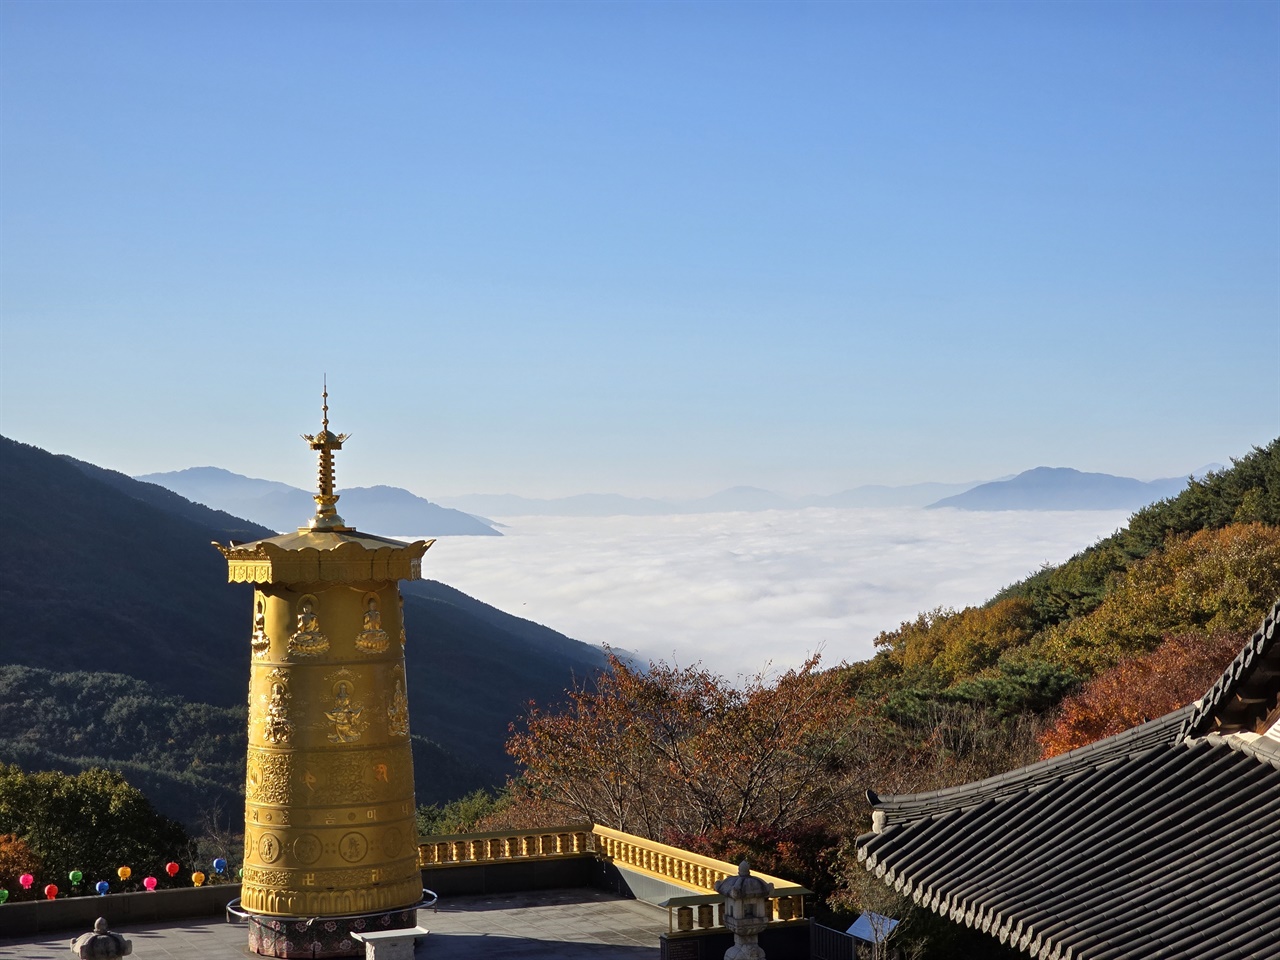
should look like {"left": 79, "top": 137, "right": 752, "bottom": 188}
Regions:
{"left": 0, "top": 888, "right": 667, "bottom": 960}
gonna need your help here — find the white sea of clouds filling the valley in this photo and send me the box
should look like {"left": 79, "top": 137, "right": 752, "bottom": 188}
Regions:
{"left": 412, "top": 508, "right": 1128, "bottom": 677}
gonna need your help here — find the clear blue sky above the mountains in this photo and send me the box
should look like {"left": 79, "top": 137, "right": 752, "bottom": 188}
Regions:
{"left": 0, "top": 0, "right": 1280, "bottom": 497}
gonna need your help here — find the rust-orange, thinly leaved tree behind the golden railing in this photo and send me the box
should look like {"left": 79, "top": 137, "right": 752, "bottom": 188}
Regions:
{"left": 507, "top": 655, "right": 858, "bottom": 840}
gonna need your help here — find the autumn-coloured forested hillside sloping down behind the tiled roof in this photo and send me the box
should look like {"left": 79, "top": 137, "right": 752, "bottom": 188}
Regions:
{"left": 481, "top": 440, "right": 1280, "bottom": 956}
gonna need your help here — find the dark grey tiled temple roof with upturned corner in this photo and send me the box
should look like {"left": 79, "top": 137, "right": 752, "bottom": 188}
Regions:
{"left": 858, "top": 599, "right": 1280, "bottom": 960}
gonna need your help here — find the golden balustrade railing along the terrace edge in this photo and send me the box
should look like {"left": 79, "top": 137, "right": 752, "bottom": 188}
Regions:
{"left": 417, "top": 823, "right": 812, "bottom": 933}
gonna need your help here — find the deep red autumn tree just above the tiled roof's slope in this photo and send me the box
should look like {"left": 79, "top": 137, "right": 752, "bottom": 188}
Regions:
{"left": 1039, "top": 632, "right": 1247, "bottom": 758}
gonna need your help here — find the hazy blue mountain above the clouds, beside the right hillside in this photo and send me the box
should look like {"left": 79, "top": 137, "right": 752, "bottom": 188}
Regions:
{"left": 928, "top": 467, "right": 1187, "bottom": 511}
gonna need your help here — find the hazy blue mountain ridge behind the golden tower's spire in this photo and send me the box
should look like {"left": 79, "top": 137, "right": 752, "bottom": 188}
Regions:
{"left": 134, "top": 467, "right": 502, "bottom": 536}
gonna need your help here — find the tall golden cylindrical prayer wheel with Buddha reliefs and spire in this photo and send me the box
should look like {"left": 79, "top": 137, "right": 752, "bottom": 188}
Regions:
{"left": 215, "top": 392, "right": 433, "bottom": 957}
